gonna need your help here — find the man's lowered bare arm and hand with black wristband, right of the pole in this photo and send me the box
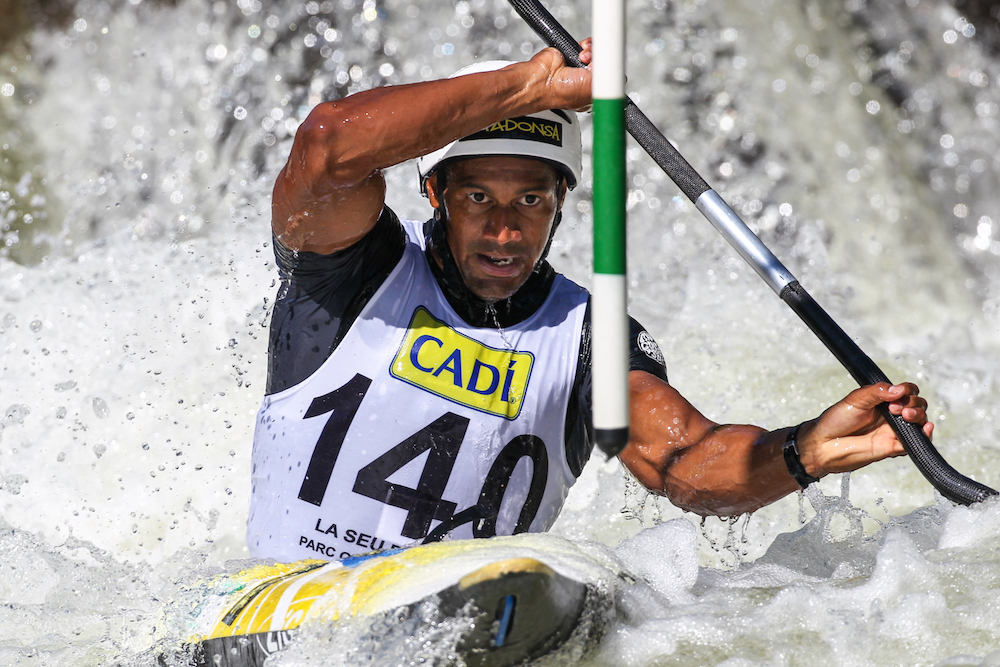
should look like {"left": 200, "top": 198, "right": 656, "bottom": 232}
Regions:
{"left": 620, "top": 371, "right": 933, "bottom": 516}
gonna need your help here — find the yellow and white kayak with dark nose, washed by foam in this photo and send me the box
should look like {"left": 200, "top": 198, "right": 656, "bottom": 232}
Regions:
{"left": 181, "top": 535, "right": 619, "bottom": 667}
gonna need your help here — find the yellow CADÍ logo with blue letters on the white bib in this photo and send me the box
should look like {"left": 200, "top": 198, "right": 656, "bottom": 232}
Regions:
{"left": 389, "top": 306, "right": 535, "bottom": 420}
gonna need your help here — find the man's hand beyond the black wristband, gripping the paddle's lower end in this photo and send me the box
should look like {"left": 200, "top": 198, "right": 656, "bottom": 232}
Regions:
{"left": 797, "top": 382, "right": 934, "bottom": 477}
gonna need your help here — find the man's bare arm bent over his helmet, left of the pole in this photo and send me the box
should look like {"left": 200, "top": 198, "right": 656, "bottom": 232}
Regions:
{"left": 271, "top": 43, "right": 590, "bottom": 254}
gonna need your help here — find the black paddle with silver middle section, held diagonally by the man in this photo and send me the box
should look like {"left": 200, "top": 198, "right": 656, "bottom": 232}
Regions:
{"left": 509, "top": 0, "right": 997, "bottom": 505}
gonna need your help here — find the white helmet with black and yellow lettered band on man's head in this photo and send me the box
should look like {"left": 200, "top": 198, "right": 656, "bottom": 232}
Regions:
{"left": 417, "top": 60, "right": 583, "bottom": 194}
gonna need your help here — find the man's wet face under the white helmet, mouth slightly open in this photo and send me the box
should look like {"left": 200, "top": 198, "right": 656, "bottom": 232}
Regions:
{"left": 428, "top": 157, "right": 566, "bottom": 301}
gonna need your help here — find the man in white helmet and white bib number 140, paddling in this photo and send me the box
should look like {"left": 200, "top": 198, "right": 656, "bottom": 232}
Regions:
{"left": 247, "top": 42, "right": 933, "bottom": 560}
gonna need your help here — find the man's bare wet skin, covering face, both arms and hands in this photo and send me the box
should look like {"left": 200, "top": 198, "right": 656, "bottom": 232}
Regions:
{"left": 272, "top": 43, "right": 932, "bottom": 516}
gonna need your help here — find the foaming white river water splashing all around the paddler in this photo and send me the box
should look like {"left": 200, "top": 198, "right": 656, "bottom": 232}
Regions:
{"left": 0, "top": 0, "right": 1000, "bottom": 667}
